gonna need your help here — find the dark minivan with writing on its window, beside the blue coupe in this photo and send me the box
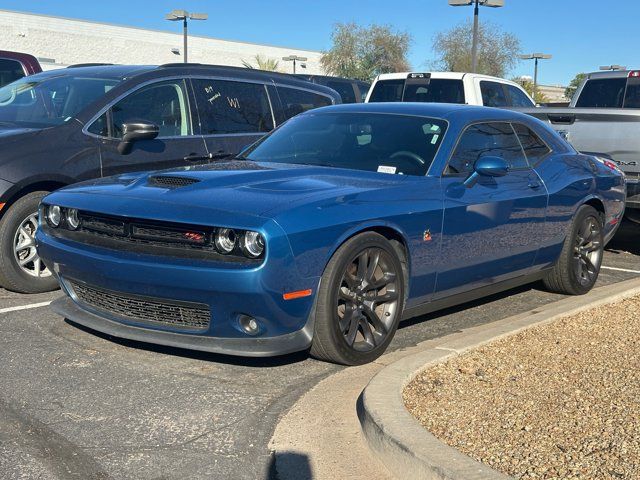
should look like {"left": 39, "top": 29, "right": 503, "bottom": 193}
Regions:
{"left": 0, "top": 64, "right": 340, "bottom": 293}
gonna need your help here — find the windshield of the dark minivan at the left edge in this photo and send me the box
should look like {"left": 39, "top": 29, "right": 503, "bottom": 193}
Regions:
{"left": 0, "top": 75, "right": 121, "bottom": 128}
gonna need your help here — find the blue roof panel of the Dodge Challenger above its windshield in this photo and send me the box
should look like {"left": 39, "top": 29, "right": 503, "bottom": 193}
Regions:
{"left": 303, "top": 102, "right": 532, "bottom": 123}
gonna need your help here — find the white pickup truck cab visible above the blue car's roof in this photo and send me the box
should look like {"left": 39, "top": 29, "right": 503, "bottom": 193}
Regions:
{"left": 366, "top": 72, "right": 535, "bottom": 108}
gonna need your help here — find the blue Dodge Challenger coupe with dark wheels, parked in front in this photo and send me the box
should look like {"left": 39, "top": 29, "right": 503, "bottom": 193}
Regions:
{"left": 36, "top": 103, "right": 625, "bottom": 365}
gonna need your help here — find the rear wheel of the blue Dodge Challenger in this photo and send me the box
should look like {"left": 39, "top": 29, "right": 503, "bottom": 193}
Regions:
{"left": 544, "top": 205, "right": 604, "bottom": 295}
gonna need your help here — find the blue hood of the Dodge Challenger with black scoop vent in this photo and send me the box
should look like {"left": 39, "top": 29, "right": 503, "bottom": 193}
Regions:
{"left": 51, "top": 161, "right": 405, "bottom": 221}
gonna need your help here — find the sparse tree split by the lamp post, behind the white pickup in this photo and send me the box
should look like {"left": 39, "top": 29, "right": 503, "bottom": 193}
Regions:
{"left": 433, "top": 21, "right": 520, "bottom": 77}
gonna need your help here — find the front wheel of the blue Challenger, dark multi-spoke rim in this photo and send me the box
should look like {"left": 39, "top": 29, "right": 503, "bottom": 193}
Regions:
{"left": 311, "top": 232, "right": 404, "bottom": 365}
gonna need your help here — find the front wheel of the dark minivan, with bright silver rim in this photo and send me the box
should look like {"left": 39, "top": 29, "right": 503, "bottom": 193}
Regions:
{"left": 0, "top": 192, "right": 58, "bottom": 293}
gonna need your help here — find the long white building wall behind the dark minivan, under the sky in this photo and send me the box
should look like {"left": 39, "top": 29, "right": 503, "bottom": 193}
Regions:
{"left": 0, "top": 10, "right": 323, "bottom": 74}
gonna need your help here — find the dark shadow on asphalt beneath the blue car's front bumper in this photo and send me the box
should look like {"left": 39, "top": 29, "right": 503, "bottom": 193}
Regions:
{"left": 64, "top": 318, "right": 310, "bottom": 367}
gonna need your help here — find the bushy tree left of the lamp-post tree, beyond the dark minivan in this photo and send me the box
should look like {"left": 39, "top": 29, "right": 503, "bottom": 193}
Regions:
{"left": 320, "top": 23, "right": 411, "bottom": 80}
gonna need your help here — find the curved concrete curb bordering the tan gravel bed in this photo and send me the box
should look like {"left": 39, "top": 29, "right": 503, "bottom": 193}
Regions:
{"left": 358, "top": 279, "right": 640, "bottom": 480}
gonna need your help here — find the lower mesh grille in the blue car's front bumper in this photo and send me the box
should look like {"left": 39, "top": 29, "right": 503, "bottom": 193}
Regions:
{"left": 69, "top": 281, "right": 211, "bottom": 330}
